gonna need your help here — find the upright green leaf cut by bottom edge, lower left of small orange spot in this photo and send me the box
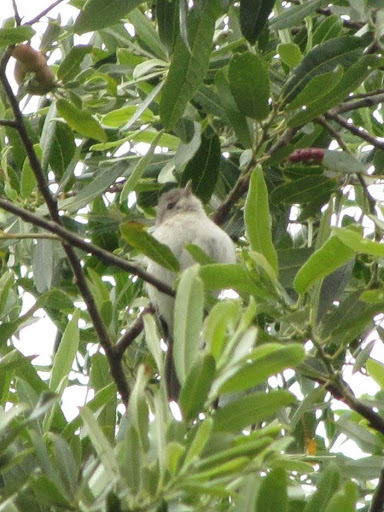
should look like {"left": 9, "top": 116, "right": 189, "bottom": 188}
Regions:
{"left": 255, "top": 467, "right": 288, "bottom": 512}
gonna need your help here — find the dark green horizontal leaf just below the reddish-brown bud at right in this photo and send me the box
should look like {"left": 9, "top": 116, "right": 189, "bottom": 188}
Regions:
{"left": 271, "top": 174, "right": 338, "bottom": 204}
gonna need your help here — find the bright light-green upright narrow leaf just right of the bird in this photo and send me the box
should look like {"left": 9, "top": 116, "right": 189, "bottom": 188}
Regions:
{"left": 244, "top": 166, "right": 278, "bottom": 276}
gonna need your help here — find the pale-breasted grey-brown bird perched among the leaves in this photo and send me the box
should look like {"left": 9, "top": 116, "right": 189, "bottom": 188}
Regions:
{"left": 147, "top": 181, "right": 236, "bottom": 398}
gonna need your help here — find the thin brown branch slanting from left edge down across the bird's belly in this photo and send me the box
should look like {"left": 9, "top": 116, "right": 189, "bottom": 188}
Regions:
{"left": 0, "top": 198, "right": 175, "bottom": 297}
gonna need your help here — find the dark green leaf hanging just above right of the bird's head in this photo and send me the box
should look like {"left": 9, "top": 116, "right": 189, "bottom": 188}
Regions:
{"left": 181, "top": 134, "right": 221, "bottom": 203}
